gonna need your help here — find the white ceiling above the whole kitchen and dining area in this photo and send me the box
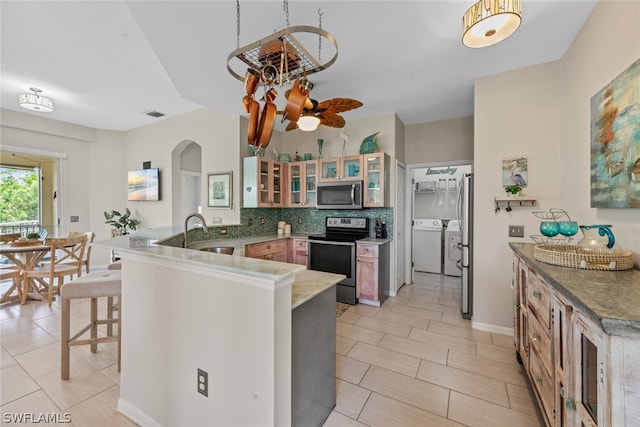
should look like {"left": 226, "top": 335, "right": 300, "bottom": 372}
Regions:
{"left": 0, "top": 0, "right": 597, "bottom": 130}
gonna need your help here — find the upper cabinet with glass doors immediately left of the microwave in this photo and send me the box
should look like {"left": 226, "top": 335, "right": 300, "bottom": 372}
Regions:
{"left": 285, "top": 160, "right": 318, "bottom": 208}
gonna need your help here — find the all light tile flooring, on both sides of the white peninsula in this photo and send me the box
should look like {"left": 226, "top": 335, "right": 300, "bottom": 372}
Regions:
{"left": 0, "top": 274, "right": 544, "bottom": 427}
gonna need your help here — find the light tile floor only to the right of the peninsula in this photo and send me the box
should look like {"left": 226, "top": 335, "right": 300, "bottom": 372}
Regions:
{"left": 324, "top": 273, "right": 544, "bottom": 427}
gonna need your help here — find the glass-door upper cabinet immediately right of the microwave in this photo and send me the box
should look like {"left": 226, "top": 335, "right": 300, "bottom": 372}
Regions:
{"left": 362, "top": 153, "right": 391, "bottom": 208}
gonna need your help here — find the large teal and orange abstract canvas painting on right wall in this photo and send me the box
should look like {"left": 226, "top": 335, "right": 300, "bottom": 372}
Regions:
{"left": 591, "top": 59, "right": 640, "bottom": 208}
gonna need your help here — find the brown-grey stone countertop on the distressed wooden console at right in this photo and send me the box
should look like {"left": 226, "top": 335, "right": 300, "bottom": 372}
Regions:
{"left": 509, "top": 243, "right": 640, "bottom": 335}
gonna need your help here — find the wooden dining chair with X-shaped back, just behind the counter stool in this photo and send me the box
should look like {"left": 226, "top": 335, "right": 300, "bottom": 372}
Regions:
{"left": 22, "top": 235, "right": 87, "bottom": 305}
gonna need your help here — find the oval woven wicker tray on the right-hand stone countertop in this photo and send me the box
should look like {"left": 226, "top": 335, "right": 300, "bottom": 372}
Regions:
{"left": 533, "top": 244, "right": 633, "bottom": 270}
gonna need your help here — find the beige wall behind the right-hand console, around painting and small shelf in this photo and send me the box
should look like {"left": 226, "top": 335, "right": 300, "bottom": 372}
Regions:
{"left": 473, "top": 1, "right": 640, "bottom": 332}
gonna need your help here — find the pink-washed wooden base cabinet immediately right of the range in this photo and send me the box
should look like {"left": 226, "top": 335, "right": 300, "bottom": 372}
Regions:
{"left": 356, "top": 241, "right": 390, "bottom": 307}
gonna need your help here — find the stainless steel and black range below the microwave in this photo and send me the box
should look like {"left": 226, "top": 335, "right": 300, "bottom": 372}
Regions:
{"left": 309, "top": 217, "right": 369, "bottom": 304}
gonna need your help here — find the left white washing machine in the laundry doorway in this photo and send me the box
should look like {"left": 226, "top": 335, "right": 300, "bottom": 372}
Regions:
{"left": 413, "top": 219, "right": 443, "bottom": 274}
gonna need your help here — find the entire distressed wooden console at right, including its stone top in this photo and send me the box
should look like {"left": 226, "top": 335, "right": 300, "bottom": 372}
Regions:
{"left": 510, "top": 243, "right": 640, "bottom": 427}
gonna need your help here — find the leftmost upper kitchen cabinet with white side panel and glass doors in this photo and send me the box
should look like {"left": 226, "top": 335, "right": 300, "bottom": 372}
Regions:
{"left": 242, "top": 156, "right": 286, "bottom": 208}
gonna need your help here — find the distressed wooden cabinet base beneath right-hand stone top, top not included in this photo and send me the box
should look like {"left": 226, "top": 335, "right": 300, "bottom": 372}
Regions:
{"left": 514, "top": 255, "right": 640, "bottom": 427}
